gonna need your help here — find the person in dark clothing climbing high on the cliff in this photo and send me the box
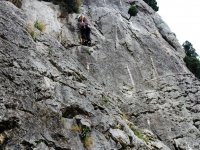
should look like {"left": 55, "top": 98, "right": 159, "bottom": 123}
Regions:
{"left": 78, "top": 15, "right": 91, "bottom": 46}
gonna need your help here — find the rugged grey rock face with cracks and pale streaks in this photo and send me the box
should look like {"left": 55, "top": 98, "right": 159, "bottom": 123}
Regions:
{"left": 0, "top": 0, "right": 200, "bottom": 150}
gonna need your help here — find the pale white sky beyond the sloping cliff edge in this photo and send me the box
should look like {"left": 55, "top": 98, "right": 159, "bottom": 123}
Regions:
{"left": 156, "top": 0, "right": 200, "bottom": 55}
